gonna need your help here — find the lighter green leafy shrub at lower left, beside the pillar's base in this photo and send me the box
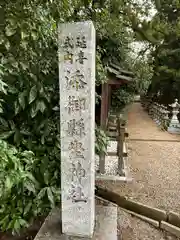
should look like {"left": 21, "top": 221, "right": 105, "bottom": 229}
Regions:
{"left": 0, "top": 140, "right": 60, "bottom": 233}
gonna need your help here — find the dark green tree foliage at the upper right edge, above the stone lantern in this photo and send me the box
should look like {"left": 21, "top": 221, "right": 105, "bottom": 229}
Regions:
{"left": 151, "top": 1, "right": 180, "bottom": 103}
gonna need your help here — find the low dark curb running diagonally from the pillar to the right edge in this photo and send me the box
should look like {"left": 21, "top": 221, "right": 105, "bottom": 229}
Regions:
{"left": 95, "top": 186, "right": 180, "bottom": 238}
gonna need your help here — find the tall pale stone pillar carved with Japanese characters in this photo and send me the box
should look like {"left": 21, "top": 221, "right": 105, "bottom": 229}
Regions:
{"left": 59, "top": 21, "right": 95, "bottom": 236}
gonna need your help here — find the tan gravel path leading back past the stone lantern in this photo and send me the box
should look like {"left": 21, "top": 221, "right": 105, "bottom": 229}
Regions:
{"left": 99, "top": 103, "right": 180, "bottom": 240}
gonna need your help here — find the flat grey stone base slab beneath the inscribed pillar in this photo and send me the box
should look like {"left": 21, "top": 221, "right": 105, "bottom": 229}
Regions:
{"left": 34, "top": 202, "right": 117, "bottom": 240}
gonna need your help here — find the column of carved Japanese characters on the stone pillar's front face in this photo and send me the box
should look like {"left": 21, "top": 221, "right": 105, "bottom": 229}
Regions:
{"left": 64, "top": 33, "right": 87, "bottom": 202}
